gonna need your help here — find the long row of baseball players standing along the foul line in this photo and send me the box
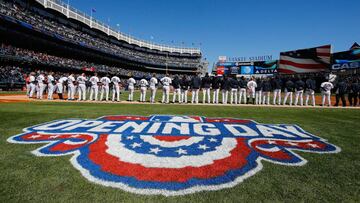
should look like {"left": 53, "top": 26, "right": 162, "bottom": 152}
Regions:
{"left": 27, "top": 72, "right": 360, "bottom": 106}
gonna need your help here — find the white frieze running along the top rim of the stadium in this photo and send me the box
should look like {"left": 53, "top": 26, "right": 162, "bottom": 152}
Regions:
{"left": 36, "top": 0, "right": 201, "bottom": 54}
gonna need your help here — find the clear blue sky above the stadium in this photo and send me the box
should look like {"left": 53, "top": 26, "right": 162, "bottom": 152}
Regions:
{"left": 69, "top": 0, "right": 360, "bottom": 71}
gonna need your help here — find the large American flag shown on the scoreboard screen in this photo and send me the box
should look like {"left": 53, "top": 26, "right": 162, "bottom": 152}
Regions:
{"left": 279, "top": 45, "right": 331, "bottom": 74}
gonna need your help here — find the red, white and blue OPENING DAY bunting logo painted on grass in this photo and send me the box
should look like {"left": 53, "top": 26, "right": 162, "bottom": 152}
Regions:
{"left": 8, "top": 115, "right": 340, "bottom": 196}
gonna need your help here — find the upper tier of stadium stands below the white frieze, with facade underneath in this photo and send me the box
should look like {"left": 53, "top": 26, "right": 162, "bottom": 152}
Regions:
{"left": 0, "top": 0, "right": 201, "bottom": 73}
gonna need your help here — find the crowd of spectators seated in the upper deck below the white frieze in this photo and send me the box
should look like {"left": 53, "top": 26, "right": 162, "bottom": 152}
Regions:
{"left": 0, "top": 0, "right": 201, "bottom": 68}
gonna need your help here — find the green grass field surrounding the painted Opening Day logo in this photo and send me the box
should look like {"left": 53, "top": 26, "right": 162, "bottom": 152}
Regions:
{"left": 0, "top": 102, "right": 360, "bottom": 202}
